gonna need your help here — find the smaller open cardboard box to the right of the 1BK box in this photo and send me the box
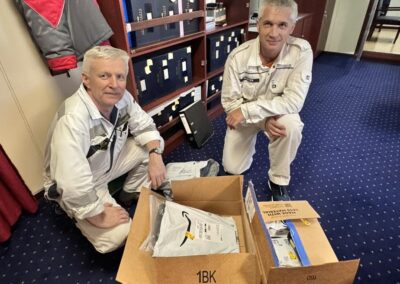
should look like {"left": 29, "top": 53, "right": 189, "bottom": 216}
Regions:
{"left": 245, "top": 185, "right": 359, "bottom": 284}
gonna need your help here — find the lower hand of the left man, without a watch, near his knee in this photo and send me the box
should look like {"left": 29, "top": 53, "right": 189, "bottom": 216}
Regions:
{"left": 86, "top": 203, "right": 129, "bottom": 229}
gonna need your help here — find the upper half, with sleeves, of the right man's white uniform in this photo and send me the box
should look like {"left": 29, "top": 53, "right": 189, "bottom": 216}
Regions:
{"left": 221, "top": 37, "right": 313, "bottom": 123}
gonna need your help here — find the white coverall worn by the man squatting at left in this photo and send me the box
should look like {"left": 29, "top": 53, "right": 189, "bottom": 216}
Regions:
{"left": 44, "top": 84, "right": 163, "bottom": 253}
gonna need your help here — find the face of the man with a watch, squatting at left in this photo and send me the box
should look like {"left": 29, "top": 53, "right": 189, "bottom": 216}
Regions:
{"left": 82, "top": 58, "right": 127, "bottom": 113}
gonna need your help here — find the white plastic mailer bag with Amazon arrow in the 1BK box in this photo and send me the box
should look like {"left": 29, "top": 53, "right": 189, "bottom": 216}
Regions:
{"left": 153, "top": 201, "right": 239, "bottom": 257}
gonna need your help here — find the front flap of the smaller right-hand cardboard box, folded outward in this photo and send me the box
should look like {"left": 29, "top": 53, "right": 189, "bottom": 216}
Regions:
{"left": 267, "top": 259, "right": 360, "bottom": 284}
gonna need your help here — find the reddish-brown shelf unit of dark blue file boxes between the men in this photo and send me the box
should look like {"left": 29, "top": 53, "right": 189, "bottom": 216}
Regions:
{"left": 98, "top": 0, "right": 248, "bottom": 152}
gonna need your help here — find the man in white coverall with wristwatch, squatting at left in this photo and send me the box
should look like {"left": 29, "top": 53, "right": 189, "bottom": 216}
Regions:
{"left": 44, "top": 46, "right": 166, "bottom": 253}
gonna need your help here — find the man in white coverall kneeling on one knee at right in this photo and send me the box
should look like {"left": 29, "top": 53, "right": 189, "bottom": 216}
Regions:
{"left": 221, "top": 0, "right": 313, "bottom": 201}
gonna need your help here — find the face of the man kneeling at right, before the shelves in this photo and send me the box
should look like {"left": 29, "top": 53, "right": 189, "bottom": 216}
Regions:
{"left": 257, "top": 5, "right": 295, "bottom": 58}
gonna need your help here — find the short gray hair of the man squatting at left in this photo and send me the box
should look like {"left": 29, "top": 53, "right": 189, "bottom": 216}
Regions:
{"left": 82, "top": 45, "right": 129, "bottom": 75}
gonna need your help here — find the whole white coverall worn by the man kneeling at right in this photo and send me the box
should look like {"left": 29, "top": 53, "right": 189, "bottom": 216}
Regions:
{"left": 221, "top": 37, "right": 313, "bottom": 185}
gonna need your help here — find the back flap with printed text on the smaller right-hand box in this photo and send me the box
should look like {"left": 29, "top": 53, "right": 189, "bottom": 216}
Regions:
{"left": 258, "top": 200, "right": 319, "bottom": 223}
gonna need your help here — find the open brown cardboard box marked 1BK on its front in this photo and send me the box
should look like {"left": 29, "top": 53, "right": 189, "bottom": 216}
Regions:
{"left": 117, "top": 176, "right": 261, "bottom": 284}
